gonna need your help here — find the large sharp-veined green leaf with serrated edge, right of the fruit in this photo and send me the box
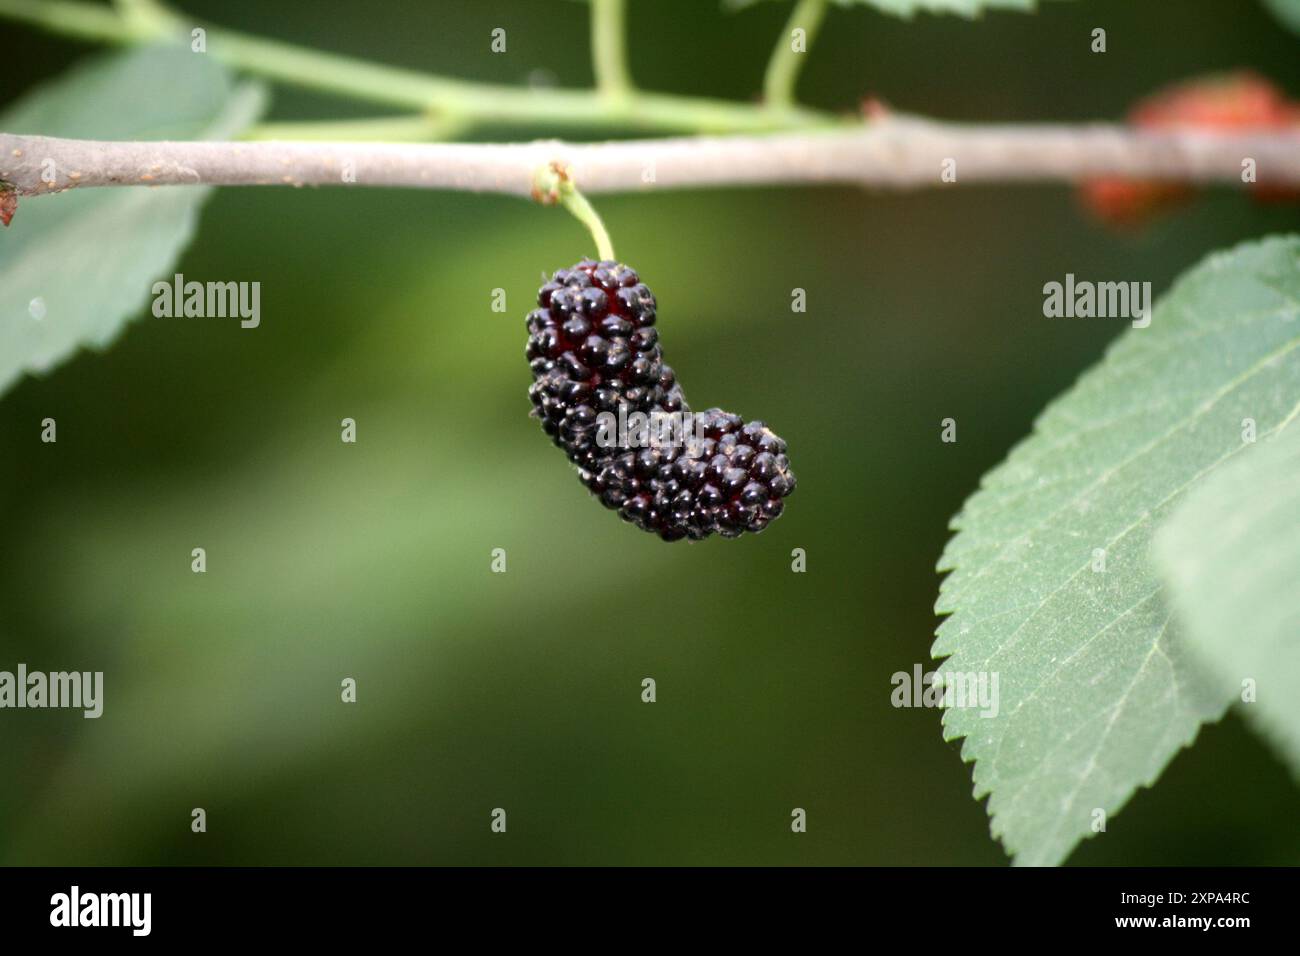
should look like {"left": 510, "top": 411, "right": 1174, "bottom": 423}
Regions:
{"left": 933, "top": 237, "right": 1300, "bottom": 865}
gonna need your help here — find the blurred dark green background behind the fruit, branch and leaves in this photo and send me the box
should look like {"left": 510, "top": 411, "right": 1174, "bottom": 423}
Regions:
{"left": 0, "top": 0, "right": 1300, "bottom": 865}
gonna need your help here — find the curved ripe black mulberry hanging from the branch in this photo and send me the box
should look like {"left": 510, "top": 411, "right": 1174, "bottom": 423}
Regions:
{"left": 527, "top": 259, "right": 794, "bottom": 541}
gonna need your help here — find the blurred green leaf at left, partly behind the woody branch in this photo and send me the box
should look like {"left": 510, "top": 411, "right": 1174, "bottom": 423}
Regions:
{"left": 0, "top": 47, "right": 264, "bottom": 393}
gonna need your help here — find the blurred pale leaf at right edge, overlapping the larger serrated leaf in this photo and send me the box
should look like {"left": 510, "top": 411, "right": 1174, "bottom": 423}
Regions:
{"left": 1156, "top": 421, "right": 1300, "bottom": 779}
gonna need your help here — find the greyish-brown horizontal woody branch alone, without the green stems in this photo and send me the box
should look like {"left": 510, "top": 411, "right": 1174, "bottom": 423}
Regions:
{"left": 0, "top": 122, "right": 1300, "bottom": 196}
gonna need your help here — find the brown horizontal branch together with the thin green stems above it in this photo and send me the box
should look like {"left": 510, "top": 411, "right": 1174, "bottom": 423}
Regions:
{"left": 0, "top": 0, "right": 1300, "bottom": 208}
